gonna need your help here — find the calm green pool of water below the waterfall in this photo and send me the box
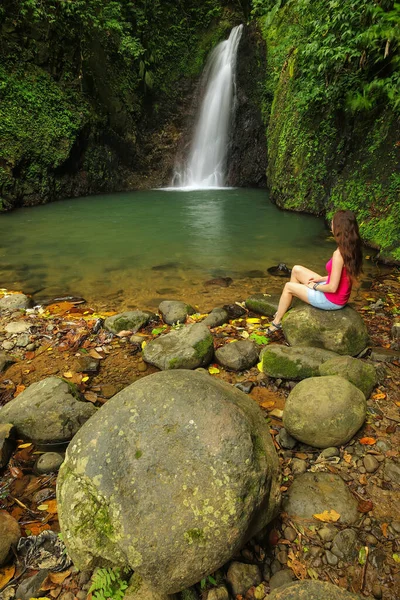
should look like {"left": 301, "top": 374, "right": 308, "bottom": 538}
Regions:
{"left": 0, "top": 189, "right": 344, "bottom": 306}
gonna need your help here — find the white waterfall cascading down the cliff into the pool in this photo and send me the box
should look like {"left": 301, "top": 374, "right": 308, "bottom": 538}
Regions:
{"left": 172, "top": 25, "right": 243, "bottom": 189}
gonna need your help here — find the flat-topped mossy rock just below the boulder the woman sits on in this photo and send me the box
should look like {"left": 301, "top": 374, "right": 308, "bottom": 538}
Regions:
{"left": 261, "top": 344, "right": 337, "bottom": 381}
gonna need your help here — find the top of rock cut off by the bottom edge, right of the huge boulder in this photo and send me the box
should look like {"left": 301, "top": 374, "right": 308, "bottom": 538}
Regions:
{"left": 268, "top": 579, "right": 365, "bottom": 600}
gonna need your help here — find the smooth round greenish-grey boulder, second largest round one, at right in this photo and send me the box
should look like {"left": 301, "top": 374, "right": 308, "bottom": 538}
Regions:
{"left": 283, "top": 375, "right": 367, "bottom": 448}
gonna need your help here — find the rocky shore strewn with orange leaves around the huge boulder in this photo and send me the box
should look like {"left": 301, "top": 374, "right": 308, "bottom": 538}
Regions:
{"left": 0, "top": 271, "right": 400, "bottom": 600}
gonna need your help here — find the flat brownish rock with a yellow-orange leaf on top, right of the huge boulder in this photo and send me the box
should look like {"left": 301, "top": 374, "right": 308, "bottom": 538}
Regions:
{"left": 283, "top": 472, "right": 358, "bottom": 524}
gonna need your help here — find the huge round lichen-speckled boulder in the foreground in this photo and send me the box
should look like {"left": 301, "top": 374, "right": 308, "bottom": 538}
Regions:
{"left": 57, "top": 370, "right": 279, "bottom": 593}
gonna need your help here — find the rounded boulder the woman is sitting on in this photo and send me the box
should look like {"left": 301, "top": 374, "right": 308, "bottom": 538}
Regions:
{"left": 282, "top": 304, "right": 369, "bottom": 356}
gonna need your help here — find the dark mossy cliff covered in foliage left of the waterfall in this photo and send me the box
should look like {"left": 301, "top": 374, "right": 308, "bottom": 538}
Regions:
{"left": 0, "top": 0, "right": 243, "bottom": 210}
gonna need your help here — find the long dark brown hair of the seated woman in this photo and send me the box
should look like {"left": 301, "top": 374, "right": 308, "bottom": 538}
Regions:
{"left": 332, "top": 210, "right": 362, "bottom": 280}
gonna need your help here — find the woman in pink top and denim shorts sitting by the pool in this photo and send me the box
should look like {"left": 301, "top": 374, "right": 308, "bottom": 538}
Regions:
{"left": 267, "top": 210, "right": 362, "bottom": 335}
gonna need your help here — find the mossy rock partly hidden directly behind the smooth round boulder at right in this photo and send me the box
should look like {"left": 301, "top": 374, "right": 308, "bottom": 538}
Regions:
{"left": 319, "top": 356, "right": 378, "bottom": 399}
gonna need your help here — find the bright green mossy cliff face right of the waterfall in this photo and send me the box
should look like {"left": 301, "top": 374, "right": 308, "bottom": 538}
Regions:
{"left": 255, "top": 0, "right": 400, "bottom": 260}
